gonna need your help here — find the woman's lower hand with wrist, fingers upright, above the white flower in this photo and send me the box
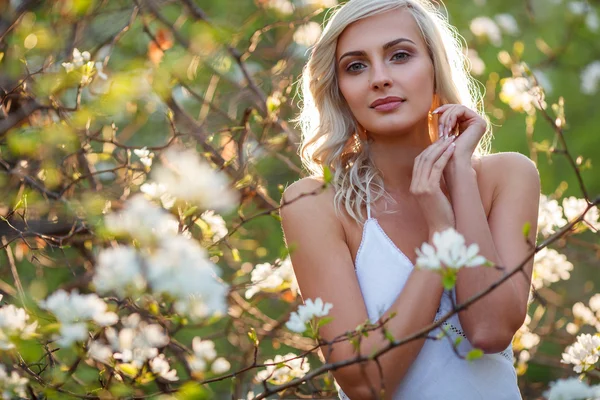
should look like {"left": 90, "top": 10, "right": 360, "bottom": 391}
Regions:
{"left": 410, "top": 136, "right": 456, "bottom": 236}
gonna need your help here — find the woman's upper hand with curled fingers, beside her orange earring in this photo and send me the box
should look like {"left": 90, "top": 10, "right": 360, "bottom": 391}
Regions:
{"left": 433, "top": 104, "right": 487, "bottom": 166}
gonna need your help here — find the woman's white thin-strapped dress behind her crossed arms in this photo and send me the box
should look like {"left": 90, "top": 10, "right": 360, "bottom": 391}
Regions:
{"left": 339, "top": 192, "right": 521, "bottom": 400}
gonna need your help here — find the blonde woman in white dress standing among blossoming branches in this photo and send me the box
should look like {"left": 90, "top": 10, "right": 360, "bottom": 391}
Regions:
{"left": 281, "top": 0, "right": 540, "bottom": 400}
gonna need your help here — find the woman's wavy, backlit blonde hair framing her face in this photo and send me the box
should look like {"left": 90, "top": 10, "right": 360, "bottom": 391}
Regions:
{"left": 296, "top": 0, "right": 491, "bottom": 223}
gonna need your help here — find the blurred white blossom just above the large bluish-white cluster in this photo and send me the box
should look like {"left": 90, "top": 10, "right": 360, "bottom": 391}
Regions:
{"left": 105, "top": 195, "right": 179, "bottom": 245}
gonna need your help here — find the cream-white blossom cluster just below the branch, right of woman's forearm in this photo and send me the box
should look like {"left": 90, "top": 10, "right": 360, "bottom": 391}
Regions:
{"left": 532, "top": 247, "right": 573, "bottom": 289}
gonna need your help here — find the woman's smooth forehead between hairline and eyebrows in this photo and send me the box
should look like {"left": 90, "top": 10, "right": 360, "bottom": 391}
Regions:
{"left": 336, "top": 8, "right": 425, "bottom": 57}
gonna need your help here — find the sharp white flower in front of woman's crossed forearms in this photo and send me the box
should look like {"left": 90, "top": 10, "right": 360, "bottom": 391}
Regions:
{"left": 416, "top": 228, "right": 486, "bottom": 269}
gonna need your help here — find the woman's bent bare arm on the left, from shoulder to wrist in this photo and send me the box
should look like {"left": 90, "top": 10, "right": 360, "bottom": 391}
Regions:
{"left": 281, "top": 179, "right": 443, "bottom": 400}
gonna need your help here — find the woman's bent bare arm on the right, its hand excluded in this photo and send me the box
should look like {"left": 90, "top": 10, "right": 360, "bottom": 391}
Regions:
{"left": 446, "top": 153, "right": 540, "bottom": 353}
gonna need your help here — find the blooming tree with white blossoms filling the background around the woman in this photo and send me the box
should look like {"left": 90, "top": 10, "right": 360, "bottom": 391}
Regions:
{"left": 0, "top": 0, "right": 600, "bottom": 400}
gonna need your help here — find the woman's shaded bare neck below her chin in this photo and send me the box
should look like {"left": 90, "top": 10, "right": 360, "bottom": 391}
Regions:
{"left": 369, "top": 121, "right": 432, "bottom": 194}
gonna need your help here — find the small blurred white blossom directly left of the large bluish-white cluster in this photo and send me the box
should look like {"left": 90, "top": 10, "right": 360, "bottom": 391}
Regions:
{"left": 93, "top": 246, "right": 146, "bottom": 298}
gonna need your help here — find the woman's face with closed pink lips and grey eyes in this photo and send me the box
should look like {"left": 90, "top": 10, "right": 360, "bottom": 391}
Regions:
{"left": 336, "top": 9, "right": 434, "bottom": 135}
